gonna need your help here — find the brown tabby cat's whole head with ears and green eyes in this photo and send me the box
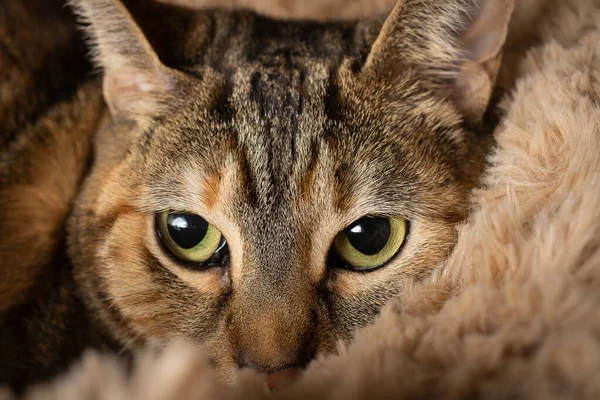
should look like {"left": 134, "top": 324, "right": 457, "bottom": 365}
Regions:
{"left": 70, "top": 0, "right": 512, "bottom": 377}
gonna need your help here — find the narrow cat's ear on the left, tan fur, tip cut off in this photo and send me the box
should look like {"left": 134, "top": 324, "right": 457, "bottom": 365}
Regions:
{"left": 71, "top": 0, "right": 182, "bottom": 123}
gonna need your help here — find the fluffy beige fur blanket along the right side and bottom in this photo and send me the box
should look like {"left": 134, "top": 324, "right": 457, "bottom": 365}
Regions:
{"left": 0, "top": 0, "right": 600, "bottom": 400}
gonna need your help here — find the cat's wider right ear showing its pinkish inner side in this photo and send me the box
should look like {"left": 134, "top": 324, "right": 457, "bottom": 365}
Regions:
{"left": 363, "top": 0, "right": 514, "bottom": 123}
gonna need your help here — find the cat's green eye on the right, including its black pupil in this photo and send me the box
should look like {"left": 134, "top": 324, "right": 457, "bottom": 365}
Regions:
{"left": 333, "top": 217, "right": 408, "bottom": 270}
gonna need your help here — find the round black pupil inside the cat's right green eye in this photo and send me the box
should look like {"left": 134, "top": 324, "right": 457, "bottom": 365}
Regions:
{"left": 346, "top": 217, "right": 392, "bottom": 256}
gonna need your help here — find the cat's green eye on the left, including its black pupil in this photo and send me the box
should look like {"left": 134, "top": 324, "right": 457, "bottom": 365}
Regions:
{"left": 156, "top": 212, "right": 225, "bottom": 263}
